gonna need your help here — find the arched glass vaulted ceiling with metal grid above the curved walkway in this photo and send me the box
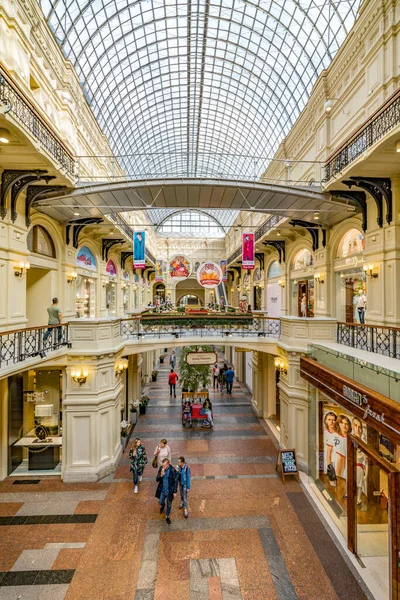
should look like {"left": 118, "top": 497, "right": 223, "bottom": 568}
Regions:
{"left": 38, "top": 0, "right": 361, "bottom": 178}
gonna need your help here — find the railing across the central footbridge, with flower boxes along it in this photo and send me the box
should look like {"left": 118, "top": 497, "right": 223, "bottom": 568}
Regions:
{"left": 121, "top": 315, "right": 281, "bottom": 342}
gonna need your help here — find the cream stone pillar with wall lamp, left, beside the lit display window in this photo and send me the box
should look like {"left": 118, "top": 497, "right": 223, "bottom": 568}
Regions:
{"left": 62, "top": 354, "right": 124, "bottom": 482}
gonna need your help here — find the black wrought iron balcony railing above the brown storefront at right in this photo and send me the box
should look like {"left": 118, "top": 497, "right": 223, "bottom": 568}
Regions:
{"left": 337, "top": 323, "right": 400, "bottom": 359}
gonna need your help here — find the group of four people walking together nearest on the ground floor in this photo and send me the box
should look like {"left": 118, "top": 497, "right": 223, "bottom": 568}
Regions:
{"left": 129, "top": 438, "right": 190, "bottom": 525}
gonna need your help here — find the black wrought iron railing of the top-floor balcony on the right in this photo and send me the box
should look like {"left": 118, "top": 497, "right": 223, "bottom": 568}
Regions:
{"left": 324, "top": 90, "right": 400, "bottom": 181}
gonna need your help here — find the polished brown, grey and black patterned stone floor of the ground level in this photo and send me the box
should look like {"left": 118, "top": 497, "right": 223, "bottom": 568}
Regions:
{"left": 0, "top": 354, "right": 368, "bottom": 600}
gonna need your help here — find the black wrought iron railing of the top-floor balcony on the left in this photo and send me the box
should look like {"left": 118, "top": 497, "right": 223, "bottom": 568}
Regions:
{"left": 0, "top": 70, "right": 75, "bottom": 178}
